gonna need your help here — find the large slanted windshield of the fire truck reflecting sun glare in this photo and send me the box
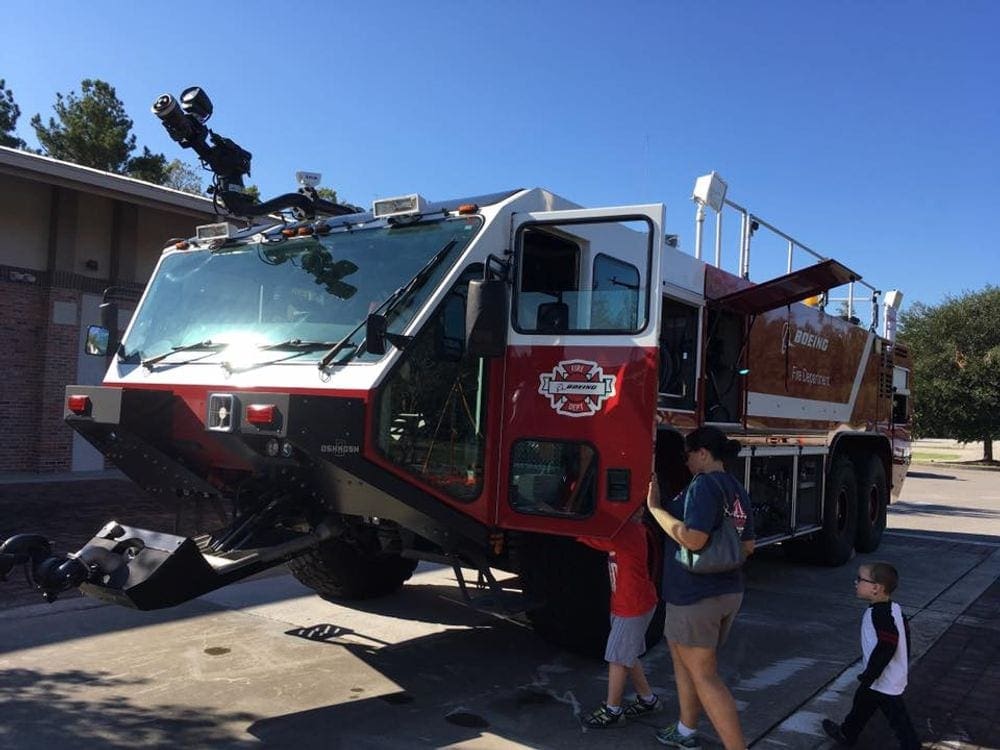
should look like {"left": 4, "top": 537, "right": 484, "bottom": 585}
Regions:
{"left": 122, "top": 217, "right": 481, "bottom": 364}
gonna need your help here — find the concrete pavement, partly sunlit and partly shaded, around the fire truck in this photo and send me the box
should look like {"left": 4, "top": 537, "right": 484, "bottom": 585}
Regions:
{"left": 0, "top": 465, "right": 1000, "bottom": 750}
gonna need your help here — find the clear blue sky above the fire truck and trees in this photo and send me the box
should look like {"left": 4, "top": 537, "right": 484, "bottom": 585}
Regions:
{"left": 0, "top": 0, "right": 1000, "bottom": 309}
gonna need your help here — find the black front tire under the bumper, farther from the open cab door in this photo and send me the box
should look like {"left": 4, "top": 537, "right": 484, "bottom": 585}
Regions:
{"left": 288, "top": 528, "right": 417, "bottom": 599}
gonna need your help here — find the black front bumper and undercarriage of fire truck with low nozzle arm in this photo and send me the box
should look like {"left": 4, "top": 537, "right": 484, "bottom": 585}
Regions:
{"left": 0, "top": 386, "right": 494, "bottom": 610}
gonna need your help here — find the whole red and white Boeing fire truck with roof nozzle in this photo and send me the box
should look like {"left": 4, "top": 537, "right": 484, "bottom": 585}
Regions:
{"left": 0, "top": 92, "right": 911, "bottom": 649}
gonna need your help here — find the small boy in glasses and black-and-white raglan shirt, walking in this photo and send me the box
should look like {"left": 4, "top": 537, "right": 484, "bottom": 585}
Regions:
{"left": 823, "top": 562, "right": 920, "bottom": 750}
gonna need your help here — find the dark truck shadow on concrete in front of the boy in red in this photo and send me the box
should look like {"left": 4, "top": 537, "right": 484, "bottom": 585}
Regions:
{"left": 246, "top": 622, "right": 673, "bottom": 748}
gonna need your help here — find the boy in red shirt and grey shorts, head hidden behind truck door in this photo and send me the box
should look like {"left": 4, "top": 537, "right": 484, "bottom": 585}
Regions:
{"left": 577, "top": 508, "right": 660, "bottom": 729}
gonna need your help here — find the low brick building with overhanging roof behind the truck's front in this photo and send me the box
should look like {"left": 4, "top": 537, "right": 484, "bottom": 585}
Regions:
{"left": 0, "top": 146, "right": 214, "bottom": 473}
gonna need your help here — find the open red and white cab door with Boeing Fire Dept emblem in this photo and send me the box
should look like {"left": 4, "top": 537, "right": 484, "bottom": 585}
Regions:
{"left": 496, "top": 204, "right": 664, "bottom": 536}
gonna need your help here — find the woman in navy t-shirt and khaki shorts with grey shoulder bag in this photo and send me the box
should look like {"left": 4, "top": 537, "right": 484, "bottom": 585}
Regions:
{"left": 646, "top": 427, "right": 755, "bottom": 750}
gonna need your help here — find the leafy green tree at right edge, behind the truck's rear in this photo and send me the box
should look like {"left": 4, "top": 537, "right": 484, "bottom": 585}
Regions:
{"left": 899, "top": 285, "right": 1000, "bottom": 462}
